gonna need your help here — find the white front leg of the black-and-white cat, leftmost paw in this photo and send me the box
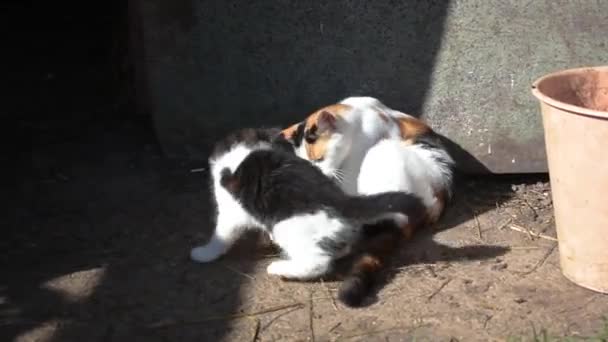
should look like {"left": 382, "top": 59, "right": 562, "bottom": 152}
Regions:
{"left": 190, "top": 214, "right": 248, "bottom": 262}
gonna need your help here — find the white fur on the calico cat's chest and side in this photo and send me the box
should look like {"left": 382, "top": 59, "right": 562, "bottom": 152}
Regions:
{"left": 296, "top": 97, "right": 452, "bottom": 216}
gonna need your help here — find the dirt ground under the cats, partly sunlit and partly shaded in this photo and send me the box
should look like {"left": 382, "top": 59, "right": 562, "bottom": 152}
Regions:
{"left": 5, "top": 118, "right": 608, "bottom": 342}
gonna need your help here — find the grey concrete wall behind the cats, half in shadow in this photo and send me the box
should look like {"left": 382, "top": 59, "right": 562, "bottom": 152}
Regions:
{"left": 133, "top": 0, "right": 608, "bottom": 173}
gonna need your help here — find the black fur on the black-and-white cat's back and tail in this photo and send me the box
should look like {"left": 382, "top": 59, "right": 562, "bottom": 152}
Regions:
{"left": 221, "top": 150, "right": 424, "bottom": 227}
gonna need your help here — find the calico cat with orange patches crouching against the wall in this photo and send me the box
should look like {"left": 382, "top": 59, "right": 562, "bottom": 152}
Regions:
{"left": 281, "top": 97, "right": 454, "bottom": 300}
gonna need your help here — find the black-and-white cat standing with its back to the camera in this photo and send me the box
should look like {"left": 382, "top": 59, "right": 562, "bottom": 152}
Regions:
{"left": 191, "top": 130, "right": 424, "bottom": 306}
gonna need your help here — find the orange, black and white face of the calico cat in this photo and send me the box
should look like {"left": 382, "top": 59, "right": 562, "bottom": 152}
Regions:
{"left": 281, "top": 104, "right": 352, "bottom": 177}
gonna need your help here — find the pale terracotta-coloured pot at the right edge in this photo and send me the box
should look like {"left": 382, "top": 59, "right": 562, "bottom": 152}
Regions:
{"left": 532, "top": 66, "right": 608, "bottom": 293}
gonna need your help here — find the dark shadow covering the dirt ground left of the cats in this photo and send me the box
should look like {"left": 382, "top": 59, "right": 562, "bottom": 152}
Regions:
{"left": 0, "top": 116, "right": 262, "bottom": 341}
